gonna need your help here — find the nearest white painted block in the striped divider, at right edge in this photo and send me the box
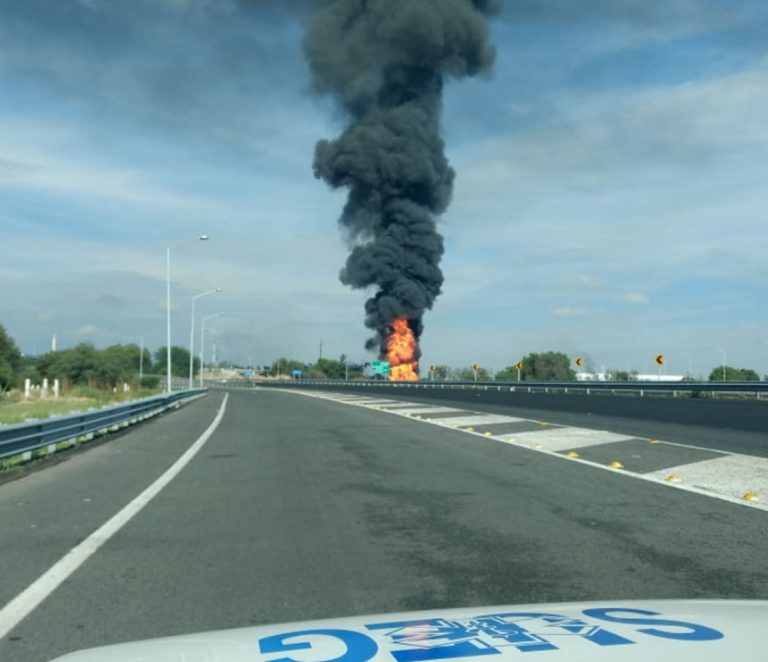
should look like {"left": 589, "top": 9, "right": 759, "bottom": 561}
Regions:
{"left": 646, "top": 455, "right": 768, "bottom": 501}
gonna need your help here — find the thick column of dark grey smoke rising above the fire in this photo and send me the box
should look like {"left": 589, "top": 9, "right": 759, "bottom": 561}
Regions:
{"left": 304, "top": 0, "right": 502, "bottom": 354}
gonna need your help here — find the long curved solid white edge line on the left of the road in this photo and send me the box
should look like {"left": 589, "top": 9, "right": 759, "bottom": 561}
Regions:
{"left": 0, "top": 393, "right": 229, "bottom": 639}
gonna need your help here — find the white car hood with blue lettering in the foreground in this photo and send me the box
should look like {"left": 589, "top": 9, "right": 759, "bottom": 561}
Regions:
{"left": 55, "top": 600, "right": 768, "bottom": 662}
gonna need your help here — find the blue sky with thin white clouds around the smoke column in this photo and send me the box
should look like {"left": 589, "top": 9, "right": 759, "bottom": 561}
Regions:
{"left": 0, "top": 0, "right": 768, "bottom": 376}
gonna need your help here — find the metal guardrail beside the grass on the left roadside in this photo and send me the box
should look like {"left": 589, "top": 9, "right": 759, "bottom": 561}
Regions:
{"left": 0, "top": 389, "right": 206, "bottom": 458}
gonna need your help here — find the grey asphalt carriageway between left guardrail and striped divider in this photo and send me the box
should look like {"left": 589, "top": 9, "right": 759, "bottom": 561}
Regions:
{"left": 0, "top": 390, "right": 768, "bottom": 662}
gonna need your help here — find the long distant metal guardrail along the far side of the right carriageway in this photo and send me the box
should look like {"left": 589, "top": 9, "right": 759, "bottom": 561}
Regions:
{"left": 232, "top": 380, "right": 768, "bottom": 399}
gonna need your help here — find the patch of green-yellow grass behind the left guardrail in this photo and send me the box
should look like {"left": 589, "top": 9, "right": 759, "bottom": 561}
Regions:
{"left": 0, "top": 387, "right": 160, "bottom": 425}
